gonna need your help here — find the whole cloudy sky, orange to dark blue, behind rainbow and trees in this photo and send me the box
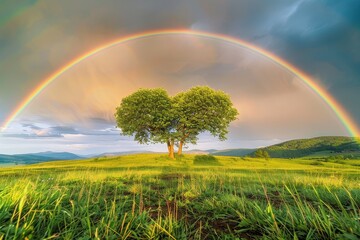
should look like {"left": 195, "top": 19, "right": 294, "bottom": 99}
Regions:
{"left": 0, "top": 0, "right": 360, "bottom": 155}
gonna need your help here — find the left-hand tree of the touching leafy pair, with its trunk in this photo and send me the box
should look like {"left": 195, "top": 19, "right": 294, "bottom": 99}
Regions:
{"left": 115, "top": 88, "right": 174, "bottom": 158}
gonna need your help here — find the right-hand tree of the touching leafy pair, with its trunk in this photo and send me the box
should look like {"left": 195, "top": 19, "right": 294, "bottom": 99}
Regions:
{"left": 173, "top": 86, "right": 238, "bottom": 155}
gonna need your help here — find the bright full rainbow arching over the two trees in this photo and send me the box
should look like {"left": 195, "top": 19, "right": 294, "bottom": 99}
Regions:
{"left": 0, "top": 29, "right": 359, "bottom": 137}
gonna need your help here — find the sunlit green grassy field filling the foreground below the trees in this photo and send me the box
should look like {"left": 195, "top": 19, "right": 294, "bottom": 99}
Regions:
{"left": 0, "top": 154, "right": 360, "bottom": 239}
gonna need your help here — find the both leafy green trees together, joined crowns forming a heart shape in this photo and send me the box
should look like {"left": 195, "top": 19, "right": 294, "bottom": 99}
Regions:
{"left": 115, "top": 87, "right": 238, "bottom": 158}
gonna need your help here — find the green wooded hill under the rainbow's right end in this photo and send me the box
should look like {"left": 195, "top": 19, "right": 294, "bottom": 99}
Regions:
{"left": 256, "top": 137, "right": 360, "bottom": 158}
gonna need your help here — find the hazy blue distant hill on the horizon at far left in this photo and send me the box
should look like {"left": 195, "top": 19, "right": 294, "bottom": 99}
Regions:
{"left": 0, "top": 152, "right": 81, "bottom": 164}
